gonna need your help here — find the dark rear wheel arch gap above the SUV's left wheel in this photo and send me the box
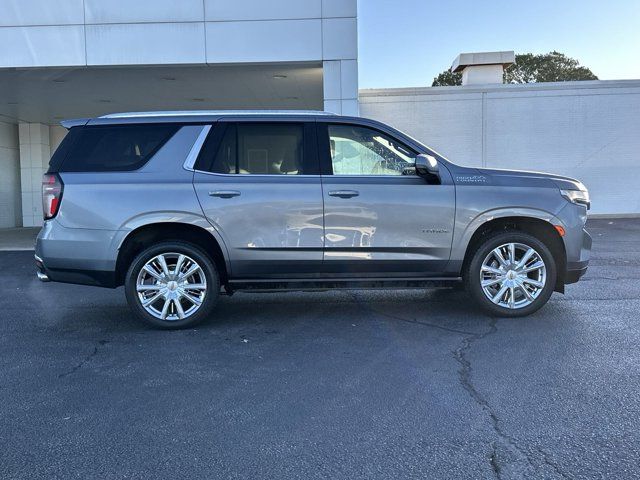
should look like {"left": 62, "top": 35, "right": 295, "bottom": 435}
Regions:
{"left": 115, "top": 221, "right": 231, "bottom": 286}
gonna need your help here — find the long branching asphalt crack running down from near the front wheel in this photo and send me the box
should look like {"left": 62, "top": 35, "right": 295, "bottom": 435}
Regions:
{"left": 453, "top": 318, "right": 571, "bottom": 480}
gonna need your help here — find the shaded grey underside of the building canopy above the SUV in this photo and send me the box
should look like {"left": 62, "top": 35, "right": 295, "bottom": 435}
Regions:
{"left": 0, "top": 63, "right": 323, "bottom": 125}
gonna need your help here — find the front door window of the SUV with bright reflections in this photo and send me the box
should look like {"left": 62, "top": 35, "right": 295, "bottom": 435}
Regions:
{"left": 329, "top": 125, "right": 415, "bottom": 175}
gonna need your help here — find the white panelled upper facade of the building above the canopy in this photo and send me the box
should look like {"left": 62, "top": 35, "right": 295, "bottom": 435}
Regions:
{"left": 0, "top": 0, "right": 357, "bottom": 68}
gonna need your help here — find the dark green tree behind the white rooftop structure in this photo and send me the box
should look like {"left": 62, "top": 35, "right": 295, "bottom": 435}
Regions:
{"left": 431, "top": 51, "right": 598, "bottom": 87}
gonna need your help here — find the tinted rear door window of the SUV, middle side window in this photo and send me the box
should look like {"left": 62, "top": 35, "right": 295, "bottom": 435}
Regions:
{"left": 204, "top": 123, "right": 304, "bottom": 175}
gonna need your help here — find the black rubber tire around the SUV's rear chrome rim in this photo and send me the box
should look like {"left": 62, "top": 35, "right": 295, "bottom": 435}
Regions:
{"left": 124, "top": 241, "right": 220, "bottom": 329}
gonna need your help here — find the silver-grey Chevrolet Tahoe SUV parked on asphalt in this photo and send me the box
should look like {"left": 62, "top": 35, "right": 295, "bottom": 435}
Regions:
{"left": 36, "top": 111, "right": 591, "bottom": 328}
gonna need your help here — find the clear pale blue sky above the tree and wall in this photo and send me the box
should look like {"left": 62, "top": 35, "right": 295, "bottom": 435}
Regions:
{"left": 358, "top": 0, "right": 640, "bottom": 88}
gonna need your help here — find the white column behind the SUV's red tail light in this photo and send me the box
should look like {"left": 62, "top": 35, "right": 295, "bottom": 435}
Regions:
{"left": 18, "top": 123, "right": 51, "bottom": 227}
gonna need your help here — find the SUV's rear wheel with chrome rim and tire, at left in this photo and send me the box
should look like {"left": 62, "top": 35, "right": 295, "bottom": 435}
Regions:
{"left": 125, "top": 242, "right": 220, "bottom": 329}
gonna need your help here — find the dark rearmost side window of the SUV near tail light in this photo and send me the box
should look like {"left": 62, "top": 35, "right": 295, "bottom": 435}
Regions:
{"left": 54, "top": 125, "right": 179, "bottom": 172}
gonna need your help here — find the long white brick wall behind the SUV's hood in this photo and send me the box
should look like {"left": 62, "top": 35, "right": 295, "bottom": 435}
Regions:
{"left": 360, "top": 80, "right": 640, "bottom": 214}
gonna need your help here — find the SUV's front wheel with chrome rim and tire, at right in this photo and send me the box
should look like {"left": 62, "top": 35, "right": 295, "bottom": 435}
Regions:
{"left": 464, "top": 232, "right": 556, "bottom": 317}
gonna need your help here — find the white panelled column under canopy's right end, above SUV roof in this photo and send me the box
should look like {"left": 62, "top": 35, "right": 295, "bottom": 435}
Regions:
{"left": 322, "top": 60, "right": 359, "bottom": 116}
